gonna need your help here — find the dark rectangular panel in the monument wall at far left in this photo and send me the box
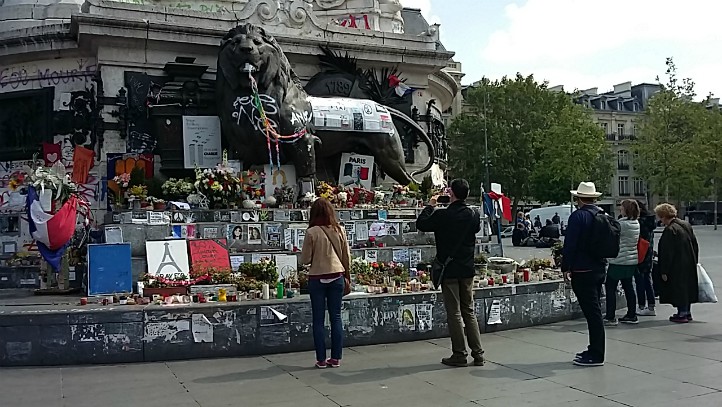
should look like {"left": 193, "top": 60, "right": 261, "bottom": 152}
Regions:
{"left": 0, "top": 88, "right": 55, "bottom": 161}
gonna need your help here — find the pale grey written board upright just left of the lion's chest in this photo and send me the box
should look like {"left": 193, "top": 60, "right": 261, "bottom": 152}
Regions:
{"left": 183, "top": 116, "right": 223, "bottom": 168}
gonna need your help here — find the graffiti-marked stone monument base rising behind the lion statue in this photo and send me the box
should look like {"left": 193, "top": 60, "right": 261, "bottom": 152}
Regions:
{"left": 0, "top": 0, "right": 459, "bottom": 251}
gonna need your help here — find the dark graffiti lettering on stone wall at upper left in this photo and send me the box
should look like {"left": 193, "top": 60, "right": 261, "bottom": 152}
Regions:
{"left": 0, "top": 59, "right": 97, "bottom": 89}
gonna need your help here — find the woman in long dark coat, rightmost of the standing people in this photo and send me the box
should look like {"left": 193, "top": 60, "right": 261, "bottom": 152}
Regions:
{"left": 654, "top": 204, "right": 699, "bottom": 323}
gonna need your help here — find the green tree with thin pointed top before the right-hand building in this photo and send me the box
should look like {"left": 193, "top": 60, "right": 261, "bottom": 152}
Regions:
{"left": 633, "top": 58, "right": 708, "bottom": 202}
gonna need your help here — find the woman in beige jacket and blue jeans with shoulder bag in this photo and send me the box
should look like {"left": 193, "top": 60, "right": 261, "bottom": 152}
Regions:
{"left": 301, "top": 199, "right": 351, "bottom": 369}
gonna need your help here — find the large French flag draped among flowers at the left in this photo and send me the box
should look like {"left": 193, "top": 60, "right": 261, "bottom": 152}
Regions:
{"left": 26, "top": 186, "right": 78, "bottom": 272}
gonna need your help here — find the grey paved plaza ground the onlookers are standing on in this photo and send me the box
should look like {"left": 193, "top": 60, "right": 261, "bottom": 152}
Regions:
{"left": 0, "top": 227, "right": 722, "bottom": 407}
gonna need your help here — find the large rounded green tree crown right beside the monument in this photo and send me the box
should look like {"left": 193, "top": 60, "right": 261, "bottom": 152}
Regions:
{"left": 449, "top": 74, "right": 612, "bottom": 207}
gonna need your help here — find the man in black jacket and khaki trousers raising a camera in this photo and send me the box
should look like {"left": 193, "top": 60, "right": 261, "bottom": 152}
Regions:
{"left": 416, "top": 179, "right": 480, "bottom": 367}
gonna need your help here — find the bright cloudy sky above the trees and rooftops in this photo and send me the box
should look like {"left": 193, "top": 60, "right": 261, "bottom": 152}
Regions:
{"left": 401, "top": 0, "right": 722, "bottom": 97}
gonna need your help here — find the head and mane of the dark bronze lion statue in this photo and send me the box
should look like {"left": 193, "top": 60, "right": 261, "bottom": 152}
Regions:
{"left": 218, "top": 24, "right": 300, "bottom": 96}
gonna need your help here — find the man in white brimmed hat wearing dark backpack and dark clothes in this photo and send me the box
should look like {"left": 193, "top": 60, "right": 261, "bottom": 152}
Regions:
{"left": 562, "top": 182, "right": 619, "bottom": 366}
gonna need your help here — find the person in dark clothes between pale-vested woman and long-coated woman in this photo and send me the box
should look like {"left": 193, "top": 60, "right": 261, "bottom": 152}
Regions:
{"left": 634, "top": 201, "right": 657, "bottom": 316}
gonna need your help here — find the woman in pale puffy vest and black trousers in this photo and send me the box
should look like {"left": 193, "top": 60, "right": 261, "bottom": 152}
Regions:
{"left": 604, "top": 199, "right": 639, "bottom": 326}
